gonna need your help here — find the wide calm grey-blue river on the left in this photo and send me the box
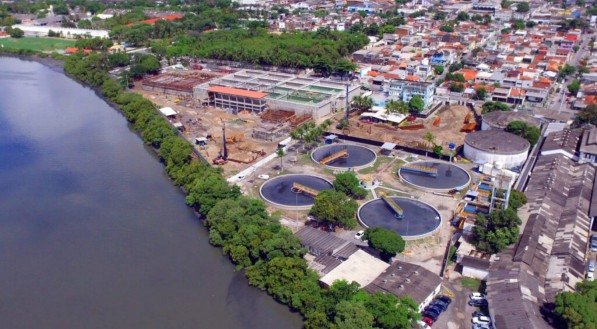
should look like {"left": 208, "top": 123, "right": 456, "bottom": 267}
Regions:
{"left": 0, "top": 58, "right": 301, "bottom": 329}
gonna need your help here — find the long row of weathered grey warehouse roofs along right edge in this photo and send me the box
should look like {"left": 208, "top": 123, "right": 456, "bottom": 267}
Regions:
{"left": 487, "top": 154, "right": 596, "bottom": 329}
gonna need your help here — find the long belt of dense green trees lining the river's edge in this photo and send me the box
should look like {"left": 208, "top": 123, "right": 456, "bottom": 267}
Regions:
{"left": 58, "top": 53, "right": 419, "bottom": 329}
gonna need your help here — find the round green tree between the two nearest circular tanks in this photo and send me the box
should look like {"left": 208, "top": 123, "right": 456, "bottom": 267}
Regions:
{"left": 310, "top": 190, "right": 359, "bottom": 229}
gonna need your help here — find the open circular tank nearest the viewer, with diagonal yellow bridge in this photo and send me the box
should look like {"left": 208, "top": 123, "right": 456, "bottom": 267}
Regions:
{"left": 357, "top": 196, "right": 441, "bottom": 240}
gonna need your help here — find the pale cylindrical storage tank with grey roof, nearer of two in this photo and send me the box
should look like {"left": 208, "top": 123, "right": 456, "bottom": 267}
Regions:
{"left": 463, "top": 129, "right": 531, "bottom": 169}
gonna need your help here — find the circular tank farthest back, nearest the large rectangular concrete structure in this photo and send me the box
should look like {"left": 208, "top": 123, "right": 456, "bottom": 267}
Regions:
{"left": 311, "top": 144, "right": 377, "bottom": 170}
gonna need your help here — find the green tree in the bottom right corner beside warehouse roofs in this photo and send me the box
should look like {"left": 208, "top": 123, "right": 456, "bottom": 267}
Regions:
{"left": 554, "top": 281, "right": 597, "bottom": 329}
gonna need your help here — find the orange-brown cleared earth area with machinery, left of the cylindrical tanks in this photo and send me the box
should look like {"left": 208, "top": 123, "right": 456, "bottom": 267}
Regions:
{"left": 331, "top": 105, "right": 481, "bottom": 150}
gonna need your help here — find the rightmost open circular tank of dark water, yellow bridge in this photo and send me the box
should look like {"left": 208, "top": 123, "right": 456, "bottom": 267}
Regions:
{"left": 398, "top": 161, "right": 471, "bottom": 192}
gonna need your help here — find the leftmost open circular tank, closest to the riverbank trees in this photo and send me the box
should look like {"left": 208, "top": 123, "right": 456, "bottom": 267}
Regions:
{"left": 259, "top": 174, "right": 332, "bottom": 210}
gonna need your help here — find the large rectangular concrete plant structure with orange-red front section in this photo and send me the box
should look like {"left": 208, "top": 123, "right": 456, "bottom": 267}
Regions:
{"left": 194, "top": 70, "right": 361, "bottom": 119}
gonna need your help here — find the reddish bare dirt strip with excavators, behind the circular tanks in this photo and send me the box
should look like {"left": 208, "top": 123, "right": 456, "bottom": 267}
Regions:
{"left": 332, "top": 105, "right": 474, "bottom": 148}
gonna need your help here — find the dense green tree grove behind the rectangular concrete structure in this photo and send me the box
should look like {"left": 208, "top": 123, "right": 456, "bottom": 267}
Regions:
{"left": 154, "top": 28, "right": 367, "bottom": 75}
